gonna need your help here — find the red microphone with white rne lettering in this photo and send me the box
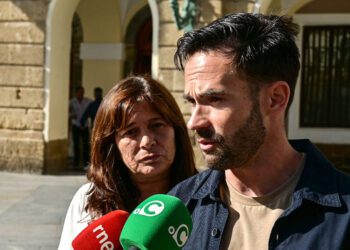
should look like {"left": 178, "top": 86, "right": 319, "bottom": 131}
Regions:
{"left": 72, "top": 210, "right": 129, "bottom": 250}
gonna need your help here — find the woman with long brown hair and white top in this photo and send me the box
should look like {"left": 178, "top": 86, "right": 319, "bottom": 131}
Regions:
{"left": 59, "top": 76, "right": 196, "bottom": 249}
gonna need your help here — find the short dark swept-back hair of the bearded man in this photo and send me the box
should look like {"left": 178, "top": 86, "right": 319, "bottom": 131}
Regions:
{"left": 174, "top": 13, "right": 300, "bottom": 107}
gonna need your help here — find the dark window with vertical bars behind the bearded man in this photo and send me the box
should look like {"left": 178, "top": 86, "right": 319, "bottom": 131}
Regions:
{"left": 300, "top": 25, "right": 350, "bottom": 128}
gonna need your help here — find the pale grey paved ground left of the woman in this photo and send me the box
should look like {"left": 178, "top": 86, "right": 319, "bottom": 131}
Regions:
{"left": 0, "top": 172, "right": 86, "bottom": 250}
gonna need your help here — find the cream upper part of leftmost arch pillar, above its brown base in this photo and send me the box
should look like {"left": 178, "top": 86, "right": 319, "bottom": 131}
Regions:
{"left": 44, "top": 0, "right": 80, "bottom": 142}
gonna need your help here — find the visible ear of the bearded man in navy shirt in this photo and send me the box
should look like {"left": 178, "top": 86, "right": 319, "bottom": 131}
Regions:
{"left": 266, "top": 81, "right": 290, "bottom": 112}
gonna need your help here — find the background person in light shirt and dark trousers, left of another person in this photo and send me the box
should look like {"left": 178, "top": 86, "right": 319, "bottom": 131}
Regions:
{"left": 69, "top": 86, "right": 91, "bottom": 167}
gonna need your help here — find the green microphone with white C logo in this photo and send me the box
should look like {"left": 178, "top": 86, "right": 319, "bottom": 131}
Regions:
{"left": 120, "top": 194, "right": 192, "bottom": 250}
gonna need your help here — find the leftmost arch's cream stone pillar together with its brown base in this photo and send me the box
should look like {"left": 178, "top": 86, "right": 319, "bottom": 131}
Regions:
{"left": 43, "top": 0, "right": 79, "bottom": 173}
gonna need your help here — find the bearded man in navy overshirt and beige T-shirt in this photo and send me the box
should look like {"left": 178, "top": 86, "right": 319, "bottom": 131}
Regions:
{"left": 170, "top": 13, "right": 350, "bottom": 250}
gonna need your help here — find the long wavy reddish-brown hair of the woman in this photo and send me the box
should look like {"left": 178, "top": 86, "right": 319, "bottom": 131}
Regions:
{"left": 86, "top": 76, "right": 196, "bottom": 217}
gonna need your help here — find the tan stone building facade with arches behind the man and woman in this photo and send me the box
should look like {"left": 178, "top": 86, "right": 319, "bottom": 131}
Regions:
{"left": 0, "top": 0, "right": 350, "bottom": 174}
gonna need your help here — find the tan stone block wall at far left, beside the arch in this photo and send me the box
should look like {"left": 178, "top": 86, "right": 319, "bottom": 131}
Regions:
{"left": 0, "top": 0, "right": 48, "bottom": 173}
